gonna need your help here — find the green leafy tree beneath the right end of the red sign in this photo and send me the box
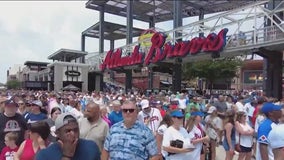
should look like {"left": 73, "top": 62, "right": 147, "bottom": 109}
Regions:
{"left": 183, "top": 57, "right": 242, "bottom": 89}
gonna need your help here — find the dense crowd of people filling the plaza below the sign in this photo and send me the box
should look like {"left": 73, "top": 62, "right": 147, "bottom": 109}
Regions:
{"left": 0, "top": 90, "right": 284, "bottom": 160}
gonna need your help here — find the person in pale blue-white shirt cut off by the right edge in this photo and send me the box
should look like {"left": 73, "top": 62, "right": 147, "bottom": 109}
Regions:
{"left": 268, "top": 124, "right": 284, "bottom": 160}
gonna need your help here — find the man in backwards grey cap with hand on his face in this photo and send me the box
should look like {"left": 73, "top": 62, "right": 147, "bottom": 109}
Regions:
{"left": 36, "top": 113, "right": 100, "bottom": 160}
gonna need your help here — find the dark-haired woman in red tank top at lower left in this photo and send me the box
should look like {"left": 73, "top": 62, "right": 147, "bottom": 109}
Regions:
{"left": 14, "top": 121, "right": 50, "bottom": 160}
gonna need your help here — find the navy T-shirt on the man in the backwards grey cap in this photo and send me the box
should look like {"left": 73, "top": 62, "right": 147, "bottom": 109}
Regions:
{"left": 35, "top": 139, "right": 100, "bottom": 160}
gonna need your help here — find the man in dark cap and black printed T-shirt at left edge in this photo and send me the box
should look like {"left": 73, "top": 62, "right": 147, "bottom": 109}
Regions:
{"left": 0, "top": 99, "right": 27, "bottom": 150}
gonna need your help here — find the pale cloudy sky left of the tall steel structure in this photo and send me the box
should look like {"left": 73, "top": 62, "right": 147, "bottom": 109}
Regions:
{"left": 0, "top": 1, "right": 93, "bottom": 83}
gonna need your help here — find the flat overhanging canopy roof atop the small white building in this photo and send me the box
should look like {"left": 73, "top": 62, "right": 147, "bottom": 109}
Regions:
{"left": 48, "top": 49, "right": 87, "bottom": 62}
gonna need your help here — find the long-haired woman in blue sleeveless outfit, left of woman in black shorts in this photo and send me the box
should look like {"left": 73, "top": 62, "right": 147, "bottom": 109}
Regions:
{"left": 223, "top": 111, "right": 236, "bottom": 160}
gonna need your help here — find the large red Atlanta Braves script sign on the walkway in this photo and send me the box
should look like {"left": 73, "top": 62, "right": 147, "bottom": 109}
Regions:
{"left": 100, "top": 28, "right": 228, "bottom": 71}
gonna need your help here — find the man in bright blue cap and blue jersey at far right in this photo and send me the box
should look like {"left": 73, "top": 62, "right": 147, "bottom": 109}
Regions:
{"left": 256, "top": 102, "right": 282, "bottom": 160}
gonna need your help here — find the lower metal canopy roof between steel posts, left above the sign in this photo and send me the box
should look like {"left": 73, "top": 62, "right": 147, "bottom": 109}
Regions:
{"left": 82, "top": 21, "right": 144, "bottom": 40}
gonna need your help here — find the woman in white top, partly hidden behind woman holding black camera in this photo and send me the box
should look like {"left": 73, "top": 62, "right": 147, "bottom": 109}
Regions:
{"left": 156, "top": 114, "right": 173, "bottom": 157}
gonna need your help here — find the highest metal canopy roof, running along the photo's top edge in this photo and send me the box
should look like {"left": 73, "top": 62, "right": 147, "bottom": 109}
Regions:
{"left": 86, "top": 0, "right": 255, "bottom": 22}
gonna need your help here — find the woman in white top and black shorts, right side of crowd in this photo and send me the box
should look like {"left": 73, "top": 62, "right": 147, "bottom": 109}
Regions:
{"left": 235, "top": 111, "right": 254, "bottom": 160}
